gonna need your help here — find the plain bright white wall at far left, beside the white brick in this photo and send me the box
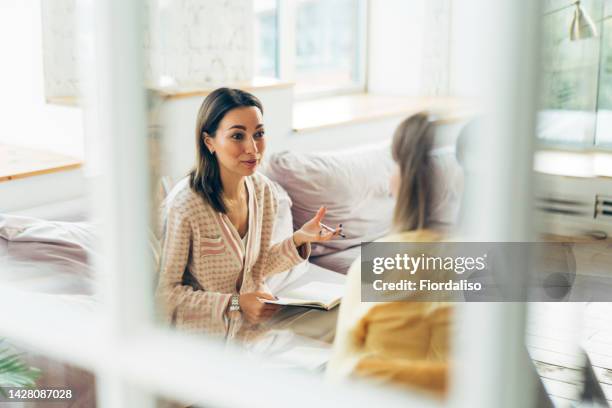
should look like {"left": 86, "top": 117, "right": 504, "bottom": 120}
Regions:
{"left": 0, "top": 0, "right": 83, "bottom": 157}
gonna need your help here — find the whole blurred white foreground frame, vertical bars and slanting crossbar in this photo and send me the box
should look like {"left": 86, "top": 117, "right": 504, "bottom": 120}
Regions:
{"left": 0, "top": 0, "right": 538, "bottom": 408}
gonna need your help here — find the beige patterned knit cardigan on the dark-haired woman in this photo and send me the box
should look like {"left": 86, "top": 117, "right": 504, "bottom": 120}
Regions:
{"left": 157, "top": 173, "right": 310, "bottom": 336}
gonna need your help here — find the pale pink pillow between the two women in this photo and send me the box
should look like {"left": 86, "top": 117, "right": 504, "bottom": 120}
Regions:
{"left": 265, "top": 143, "right": 394, "bottom": 256}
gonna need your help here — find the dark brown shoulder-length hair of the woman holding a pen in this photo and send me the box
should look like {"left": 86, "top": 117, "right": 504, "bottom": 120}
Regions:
{"left": 189, "top": 88, "right": 263, "bottom": 213}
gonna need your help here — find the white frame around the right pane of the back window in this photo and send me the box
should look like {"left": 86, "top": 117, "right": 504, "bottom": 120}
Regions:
{"left": 277, "top": 0, "right": 370, "bottom": 100}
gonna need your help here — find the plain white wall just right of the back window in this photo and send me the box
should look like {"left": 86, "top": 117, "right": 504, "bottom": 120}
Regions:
{"left": 368, "top": 0, "right": 451, "bottom": 96}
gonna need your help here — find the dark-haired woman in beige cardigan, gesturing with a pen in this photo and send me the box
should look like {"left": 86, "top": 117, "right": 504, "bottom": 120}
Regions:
{"left": 157, "top": 88, "right": 340, "bottom": 336}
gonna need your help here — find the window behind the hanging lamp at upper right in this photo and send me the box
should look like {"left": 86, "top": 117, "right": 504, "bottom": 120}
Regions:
{"left": 538, "top": 0, "right": 612, "bottom": 148}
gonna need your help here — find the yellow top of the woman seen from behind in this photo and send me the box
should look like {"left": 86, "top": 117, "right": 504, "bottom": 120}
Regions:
{"left": 327, "top": 230, "right": 453, "bottom": 395}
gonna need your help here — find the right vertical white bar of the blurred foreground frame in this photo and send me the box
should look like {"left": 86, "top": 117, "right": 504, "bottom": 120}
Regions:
{"left": 451, "top": 0, "right": 539, "bottom": 407}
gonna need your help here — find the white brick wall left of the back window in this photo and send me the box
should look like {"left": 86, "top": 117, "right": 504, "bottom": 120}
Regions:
{"left": 39, "top": 0, "right": 254, "bottom": 97}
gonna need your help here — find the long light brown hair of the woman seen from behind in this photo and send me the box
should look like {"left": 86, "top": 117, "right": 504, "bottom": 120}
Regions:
{"left": 391, "top": 112, "right": 435, "bottom": 231}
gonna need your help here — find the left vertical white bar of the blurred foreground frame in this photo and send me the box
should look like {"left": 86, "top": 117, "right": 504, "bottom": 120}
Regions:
{"left": 84, "top": 0, "right": 154, "bottom": 408}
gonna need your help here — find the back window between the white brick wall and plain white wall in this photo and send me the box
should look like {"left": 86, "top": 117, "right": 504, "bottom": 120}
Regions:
{"left": 255, "top": 0, "right": 366, "bottom": 96}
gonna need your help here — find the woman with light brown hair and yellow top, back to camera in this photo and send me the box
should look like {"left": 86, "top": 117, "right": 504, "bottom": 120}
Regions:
{"left": 327, "top": 113, "right": 462, "bottom": 395}
